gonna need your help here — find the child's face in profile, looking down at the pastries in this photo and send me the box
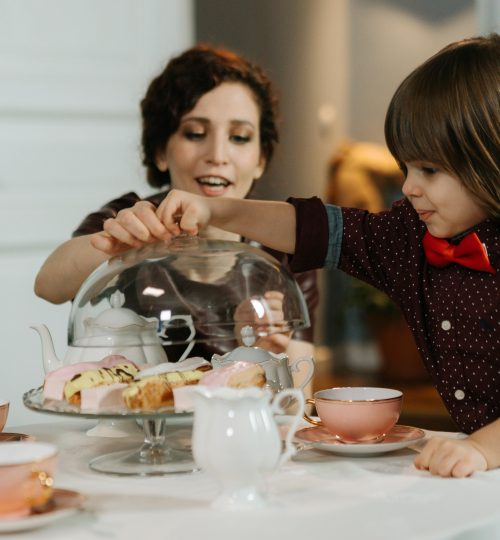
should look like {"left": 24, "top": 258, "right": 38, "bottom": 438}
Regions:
{"left": 403, "top": 161, "right": 487, "bottom": 238}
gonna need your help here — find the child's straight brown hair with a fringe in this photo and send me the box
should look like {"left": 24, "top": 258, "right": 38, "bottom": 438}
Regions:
{"left": 385, "top": 34, "right": 500, "bottom": 220}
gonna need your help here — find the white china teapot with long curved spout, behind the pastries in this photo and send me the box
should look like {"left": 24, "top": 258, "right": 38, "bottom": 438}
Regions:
{"left": 31, "top": 291, "right": 167, "bottom": 373}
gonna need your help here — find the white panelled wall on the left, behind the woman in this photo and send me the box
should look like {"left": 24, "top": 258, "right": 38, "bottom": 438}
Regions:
{"left": 0, "top": 0, "right": 194, "bottom": 425}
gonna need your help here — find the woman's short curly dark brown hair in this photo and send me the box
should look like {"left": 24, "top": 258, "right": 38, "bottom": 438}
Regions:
{"left": 141, "top": 44, "right": 278, "bottom": 188}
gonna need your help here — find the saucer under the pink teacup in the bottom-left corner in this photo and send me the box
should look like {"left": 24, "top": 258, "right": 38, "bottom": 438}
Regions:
{"left": 0, "top": 489, "right": 84, "bottom": 533}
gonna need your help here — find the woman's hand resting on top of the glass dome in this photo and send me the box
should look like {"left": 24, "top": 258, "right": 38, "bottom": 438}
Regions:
{"left": 90, "top": 201, "right": 172, "bottom": 255}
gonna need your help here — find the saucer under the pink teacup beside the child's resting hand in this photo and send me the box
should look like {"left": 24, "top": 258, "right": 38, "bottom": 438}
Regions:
{"left": 295, "top": 424, "right": 425, "bottom": 456}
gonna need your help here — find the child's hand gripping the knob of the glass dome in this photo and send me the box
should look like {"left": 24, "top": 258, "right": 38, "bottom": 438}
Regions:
{"left": 156, "top": 189, "right": 211, "bottom": 236}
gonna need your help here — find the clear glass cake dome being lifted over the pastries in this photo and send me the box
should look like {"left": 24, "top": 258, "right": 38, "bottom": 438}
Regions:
{"left": 68, "top": 236, "right": 310, "bottom": 364}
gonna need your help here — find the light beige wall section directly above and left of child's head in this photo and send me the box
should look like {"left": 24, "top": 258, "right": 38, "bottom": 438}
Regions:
{"left": 347, "top": 0, "right": 478, "bottom": 144}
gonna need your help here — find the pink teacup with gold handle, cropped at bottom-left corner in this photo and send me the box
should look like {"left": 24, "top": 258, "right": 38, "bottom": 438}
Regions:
{"left": 0, "top": 442, "right": 57, "bottom": 519}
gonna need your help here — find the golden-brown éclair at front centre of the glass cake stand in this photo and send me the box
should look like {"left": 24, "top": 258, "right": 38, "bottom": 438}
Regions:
{"left": 123, "top": 370, "right": 203, "bottom": 409}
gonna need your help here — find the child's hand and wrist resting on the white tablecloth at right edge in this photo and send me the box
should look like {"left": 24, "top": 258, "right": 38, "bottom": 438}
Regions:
{"left": 415, "top": 418, "right": 500, "bottom": 478}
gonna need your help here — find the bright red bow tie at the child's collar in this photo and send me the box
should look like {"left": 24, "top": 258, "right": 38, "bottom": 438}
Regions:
{"left": 423, "top": 231, "right": 496, "bottom": 274}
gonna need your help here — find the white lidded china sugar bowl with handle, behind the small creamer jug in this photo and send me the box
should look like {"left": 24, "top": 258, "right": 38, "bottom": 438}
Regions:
{"left": 211, "top": 326, "right": 314, "bottom": 392}
